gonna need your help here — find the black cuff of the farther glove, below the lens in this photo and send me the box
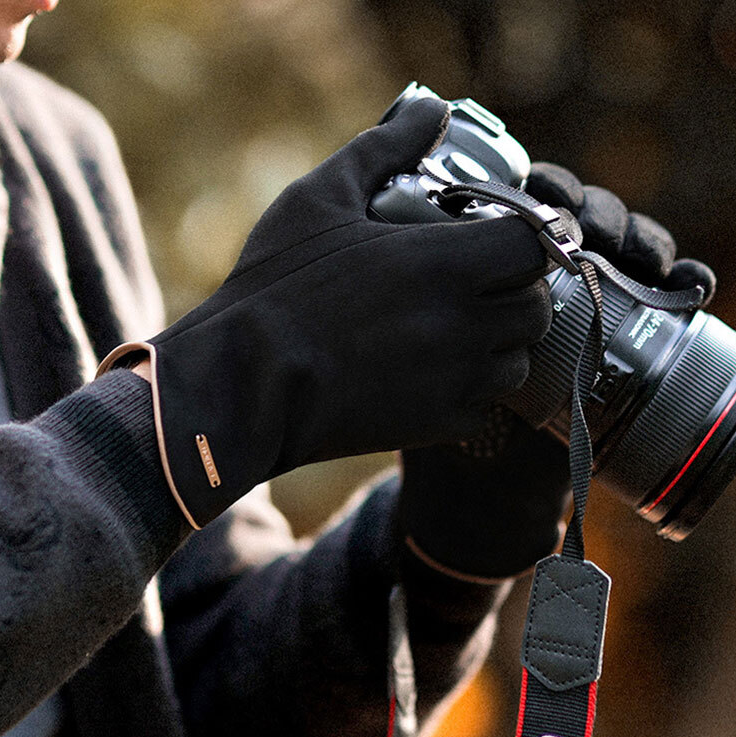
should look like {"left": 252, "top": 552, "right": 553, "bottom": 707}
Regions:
{"left": 401, "top": 434, "right": 569, "bottom": 583}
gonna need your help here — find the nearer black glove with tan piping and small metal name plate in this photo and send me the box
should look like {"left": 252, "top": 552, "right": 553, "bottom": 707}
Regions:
{"left": 102, "top": 100, "right": 551, "bottom": 526}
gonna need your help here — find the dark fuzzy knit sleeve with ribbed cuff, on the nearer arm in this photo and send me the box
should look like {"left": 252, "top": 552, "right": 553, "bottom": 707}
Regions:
{"left": 0, "top": 370, "right": 186, "bottom": 733}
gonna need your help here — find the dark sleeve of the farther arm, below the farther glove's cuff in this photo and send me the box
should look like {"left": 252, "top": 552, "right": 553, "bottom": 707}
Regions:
{"left": 161, "top": 476, "right": 508, "bottom": 737}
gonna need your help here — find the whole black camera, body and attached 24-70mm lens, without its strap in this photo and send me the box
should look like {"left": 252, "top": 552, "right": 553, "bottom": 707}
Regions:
{"left": 368, "top": 83, "right": 736, "bottom": 540}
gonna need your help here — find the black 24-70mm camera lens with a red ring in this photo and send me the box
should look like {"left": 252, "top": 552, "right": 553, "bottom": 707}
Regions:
{"left": 508, "top": 270, "right": 736, "bottom": 540}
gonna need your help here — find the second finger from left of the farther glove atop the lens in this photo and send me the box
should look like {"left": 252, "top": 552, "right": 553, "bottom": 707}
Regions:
{"left": 578, "top": 186, "right": 629, "bottom": 262}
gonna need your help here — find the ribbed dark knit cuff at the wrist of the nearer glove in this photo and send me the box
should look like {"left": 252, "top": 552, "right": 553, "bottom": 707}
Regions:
{"left": 31, "top": 369, "right": 191, "bottom": 574}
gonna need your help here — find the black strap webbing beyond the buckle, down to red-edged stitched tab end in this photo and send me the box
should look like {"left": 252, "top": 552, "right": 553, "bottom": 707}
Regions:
{"left": 516, "top": 251, "right": 703, "bottom": 737}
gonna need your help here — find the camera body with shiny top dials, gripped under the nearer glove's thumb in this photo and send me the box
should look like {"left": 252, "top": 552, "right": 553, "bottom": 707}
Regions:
{"left": 369, "top": 82, "right": 531, "bottom": 223}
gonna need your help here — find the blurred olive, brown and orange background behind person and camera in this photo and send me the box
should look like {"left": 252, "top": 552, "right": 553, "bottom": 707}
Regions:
{"left": 24, "top": 0, "right": 736, "bottom": 737}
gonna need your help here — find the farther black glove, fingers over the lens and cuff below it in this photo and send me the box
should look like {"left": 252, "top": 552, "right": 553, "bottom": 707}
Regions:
{"left": 401, "top": 163, "right": 715, "bottom": 579}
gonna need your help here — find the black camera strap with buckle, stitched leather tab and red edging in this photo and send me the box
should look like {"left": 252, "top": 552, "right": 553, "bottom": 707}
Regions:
{"left": 389, "top": 182, "right": 704, "bottom": 737}
